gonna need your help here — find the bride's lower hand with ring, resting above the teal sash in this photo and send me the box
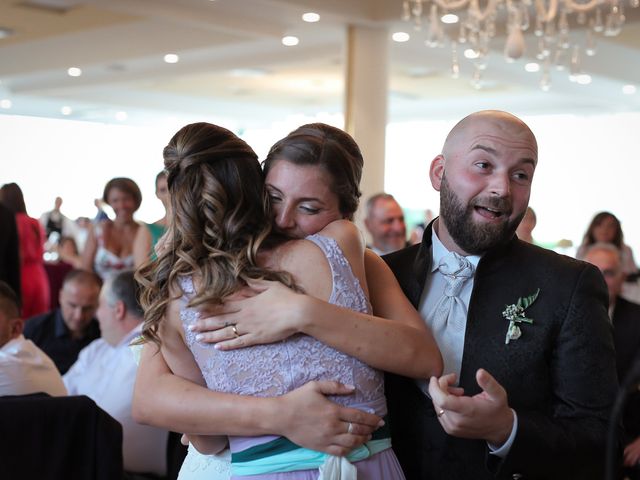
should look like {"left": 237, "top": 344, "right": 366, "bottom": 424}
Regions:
{"left": 276, "top": 381, "right": 384, "bottom": 456}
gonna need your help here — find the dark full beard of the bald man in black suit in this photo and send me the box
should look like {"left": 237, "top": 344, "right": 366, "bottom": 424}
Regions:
{"left": 440, "top": 175, "right": 525, "bottom": 255}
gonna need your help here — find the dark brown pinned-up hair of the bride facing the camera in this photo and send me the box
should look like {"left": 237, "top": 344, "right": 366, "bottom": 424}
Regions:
{"left": 264, "top": 123, "right": 364, "bottom": 220}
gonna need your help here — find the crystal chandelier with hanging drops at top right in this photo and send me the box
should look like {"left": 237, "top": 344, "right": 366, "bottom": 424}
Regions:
{"left": 402, "top": 0, "right": 640, "bottom": 91}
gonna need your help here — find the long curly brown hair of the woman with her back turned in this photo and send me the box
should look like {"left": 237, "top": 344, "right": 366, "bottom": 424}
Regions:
{"left": 136, "top": 122, "right": 295, "bottom": 344}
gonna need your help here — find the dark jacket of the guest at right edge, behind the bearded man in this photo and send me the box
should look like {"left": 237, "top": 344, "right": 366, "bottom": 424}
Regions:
{"left": 612, "top": 297, "right": 640, "bottom": 441}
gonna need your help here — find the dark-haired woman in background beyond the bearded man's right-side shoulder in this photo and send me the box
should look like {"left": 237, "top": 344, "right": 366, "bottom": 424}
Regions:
{"left": 576, "top": 212, "right": 638, "bottom": 275}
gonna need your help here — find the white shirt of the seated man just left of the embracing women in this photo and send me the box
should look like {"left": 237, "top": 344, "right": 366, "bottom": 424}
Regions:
{"left": 63, "top": 325, "right": 168, "bottom": 475}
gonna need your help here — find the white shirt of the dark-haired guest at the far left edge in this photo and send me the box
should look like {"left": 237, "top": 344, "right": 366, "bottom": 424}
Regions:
{"left": 0, "top": 335, "right": 67, "bottom": 397}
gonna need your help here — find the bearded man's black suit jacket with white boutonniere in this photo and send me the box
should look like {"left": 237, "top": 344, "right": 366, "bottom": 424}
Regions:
{"left": 384, "top": 221, "right": 617, "bottom": 480}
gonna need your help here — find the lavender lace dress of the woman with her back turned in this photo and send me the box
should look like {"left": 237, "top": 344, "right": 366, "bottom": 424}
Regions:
{"left": 180, "top": 235, "right": 404, "bottom": 480}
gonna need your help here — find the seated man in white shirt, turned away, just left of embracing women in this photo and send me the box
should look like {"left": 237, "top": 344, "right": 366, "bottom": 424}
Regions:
{"left": 64, "top": 270, "right": 168, "bottom": 475}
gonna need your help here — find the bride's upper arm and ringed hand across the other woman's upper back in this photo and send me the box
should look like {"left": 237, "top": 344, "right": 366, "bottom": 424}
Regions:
{"left": 196, "top": 222, "right": 442, "bottom": 378}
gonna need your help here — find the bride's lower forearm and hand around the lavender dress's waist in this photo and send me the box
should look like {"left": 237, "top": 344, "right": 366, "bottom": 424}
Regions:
{"left": 132, "top": 344, "right": 381, "bottom": 455}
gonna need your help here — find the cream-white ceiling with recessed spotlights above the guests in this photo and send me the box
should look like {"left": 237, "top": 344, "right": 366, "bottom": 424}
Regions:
{"left": 0, "top": 0, "right": 640, "bottom": 126}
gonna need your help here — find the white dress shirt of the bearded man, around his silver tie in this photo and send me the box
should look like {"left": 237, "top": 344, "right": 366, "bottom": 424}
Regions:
{"left": 417, "top": 229, "right": 518, "bottom": 458}
